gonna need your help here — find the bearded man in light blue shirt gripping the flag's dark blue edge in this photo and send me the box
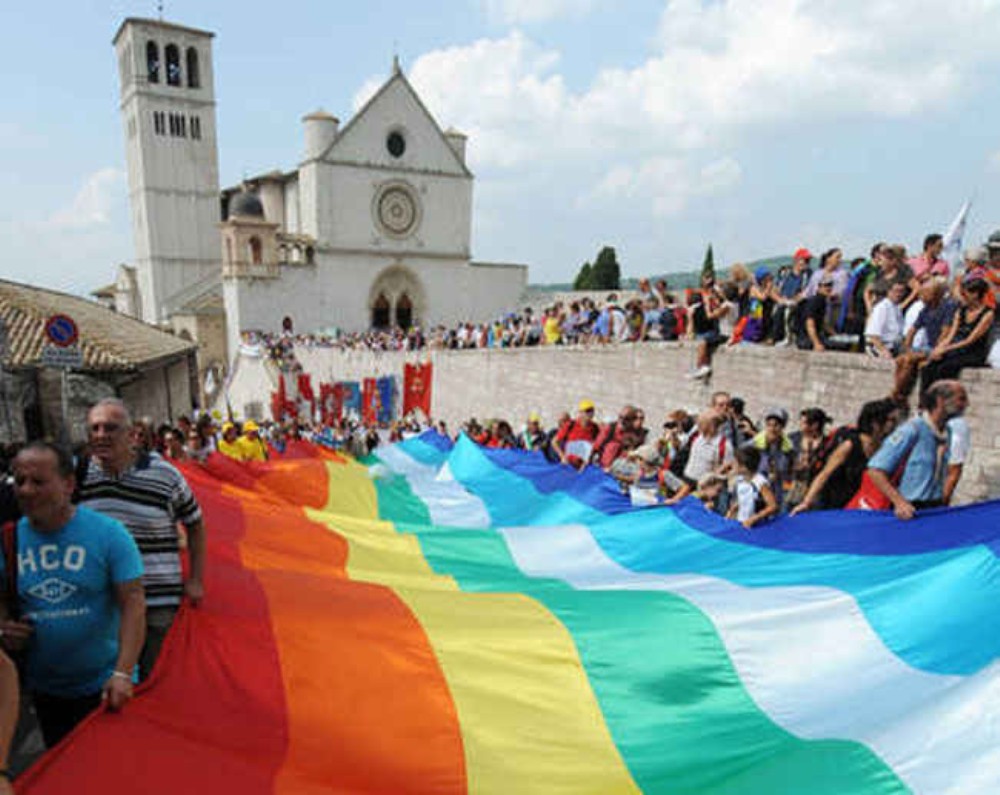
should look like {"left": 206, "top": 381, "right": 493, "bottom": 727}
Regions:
{"left": 868, "top": 380, "right": 969, "bottom": 519}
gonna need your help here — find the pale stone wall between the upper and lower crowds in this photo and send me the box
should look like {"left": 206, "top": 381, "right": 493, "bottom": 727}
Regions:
{"left": 284, "top": 342, "right": 1000, "bottom": 501}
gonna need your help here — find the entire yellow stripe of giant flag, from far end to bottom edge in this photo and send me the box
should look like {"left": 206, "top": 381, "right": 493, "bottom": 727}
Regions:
{"left": 307, "top": 464, "right": 638, "bottom": 793}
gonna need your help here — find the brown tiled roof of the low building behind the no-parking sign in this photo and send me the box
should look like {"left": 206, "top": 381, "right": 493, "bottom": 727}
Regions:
{"left": 0, "top": 279, "right": 197, "bottom": 371}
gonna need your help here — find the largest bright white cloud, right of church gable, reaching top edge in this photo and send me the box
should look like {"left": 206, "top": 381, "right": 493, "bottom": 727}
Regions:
{"left": 386, "top": 0, "right": 1000, "bottom": 172}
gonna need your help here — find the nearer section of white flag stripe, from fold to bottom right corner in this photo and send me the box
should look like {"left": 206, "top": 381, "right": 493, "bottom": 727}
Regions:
{"left": 500, "top": 525, "right": 1000, "bottom": 795}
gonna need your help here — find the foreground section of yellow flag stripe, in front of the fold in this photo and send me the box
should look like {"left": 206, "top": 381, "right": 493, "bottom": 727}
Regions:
{"left": 399, "top": 589, "right": 639, "bottom": 794}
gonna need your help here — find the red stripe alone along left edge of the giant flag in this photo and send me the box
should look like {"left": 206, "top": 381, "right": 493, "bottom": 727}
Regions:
{"left": 18, "top": 475, "right": 288, "bottom": 795}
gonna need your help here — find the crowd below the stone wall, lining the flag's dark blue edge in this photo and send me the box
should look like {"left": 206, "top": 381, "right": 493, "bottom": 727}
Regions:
{"left": 450, "top": 379, "right": 971, "bottom": 528}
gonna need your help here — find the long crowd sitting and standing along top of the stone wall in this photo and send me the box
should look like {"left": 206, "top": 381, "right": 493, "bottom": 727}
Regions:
{"left": 236, "top": 234, "right": 1000, "bottom": 399}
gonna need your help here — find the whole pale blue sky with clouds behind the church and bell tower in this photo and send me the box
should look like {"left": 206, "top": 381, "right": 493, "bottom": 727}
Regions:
{"left": 0, "top": 0, "right": 1000, "bottom": 293}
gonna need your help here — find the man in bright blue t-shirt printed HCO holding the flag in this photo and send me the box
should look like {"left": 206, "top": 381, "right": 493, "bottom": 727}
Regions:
{"left": 0, "top": 442, "right": 146, "bottom": 748}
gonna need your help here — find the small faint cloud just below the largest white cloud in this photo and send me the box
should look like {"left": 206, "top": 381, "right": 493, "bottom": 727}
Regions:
{"left": 581, "top": 157, "right": 743, "bottom": 217}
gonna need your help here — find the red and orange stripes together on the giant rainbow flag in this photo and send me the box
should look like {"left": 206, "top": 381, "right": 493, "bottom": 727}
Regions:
{"left": 18, "top": 450, "right": 467, "bottom": 795}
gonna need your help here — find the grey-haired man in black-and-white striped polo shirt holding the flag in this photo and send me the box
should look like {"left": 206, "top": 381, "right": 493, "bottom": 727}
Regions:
{"left": 79, "top": 398, "right": 205, "bottom": 679}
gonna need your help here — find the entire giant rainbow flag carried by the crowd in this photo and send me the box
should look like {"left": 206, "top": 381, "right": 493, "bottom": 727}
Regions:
{"left": 19, "top": 433, "right": 1000, "bottom": 795}
